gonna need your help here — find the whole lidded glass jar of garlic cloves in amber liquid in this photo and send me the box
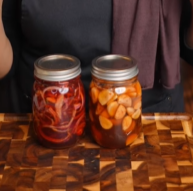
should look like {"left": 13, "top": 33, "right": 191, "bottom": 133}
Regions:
{"left": 89, "top": 55, "right": 142, "bottom": 149}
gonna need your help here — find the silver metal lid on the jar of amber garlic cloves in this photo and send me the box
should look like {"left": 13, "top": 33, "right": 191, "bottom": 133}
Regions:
{"left": 91, "top": 54, "right": 139, "bottom": 81}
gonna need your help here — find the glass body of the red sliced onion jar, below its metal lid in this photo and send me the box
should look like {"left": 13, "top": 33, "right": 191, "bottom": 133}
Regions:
{"left": 33, "top": 76, "right": 86, "bottom": 149}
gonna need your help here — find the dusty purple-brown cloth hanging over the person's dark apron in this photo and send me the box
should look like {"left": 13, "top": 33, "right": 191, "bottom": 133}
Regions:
{"left": 112, "top": 0, "right": 182, "bottom": 89}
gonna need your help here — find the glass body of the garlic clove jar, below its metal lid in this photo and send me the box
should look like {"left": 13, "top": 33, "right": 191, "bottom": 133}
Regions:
{"left": 89, "top": 76, "right": 142, "bottom": 149}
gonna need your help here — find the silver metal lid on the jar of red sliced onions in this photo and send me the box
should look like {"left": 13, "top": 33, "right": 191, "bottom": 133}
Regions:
{"left": 34, "top": 54, "right": 81, "bottom": 81}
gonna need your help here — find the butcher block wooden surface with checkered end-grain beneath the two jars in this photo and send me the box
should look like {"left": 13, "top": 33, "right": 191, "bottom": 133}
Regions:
{"left": 0, "top": 113, "right": 193, "bottom": 191}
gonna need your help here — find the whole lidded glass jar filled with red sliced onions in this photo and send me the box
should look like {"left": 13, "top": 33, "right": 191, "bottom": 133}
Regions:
{"left": 33, "top": 55, "right": 86, "bottom": 149}
